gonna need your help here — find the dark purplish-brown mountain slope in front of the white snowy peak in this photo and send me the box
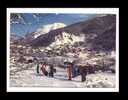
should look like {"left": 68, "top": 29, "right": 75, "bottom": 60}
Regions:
{"left": 30, "top": 15, "right": 116, "bottom": 51}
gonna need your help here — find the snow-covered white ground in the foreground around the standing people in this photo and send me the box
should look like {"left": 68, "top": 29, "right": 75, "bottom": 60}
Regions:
{"left": 10, "top": 67, "right": 115, "bottom": 88}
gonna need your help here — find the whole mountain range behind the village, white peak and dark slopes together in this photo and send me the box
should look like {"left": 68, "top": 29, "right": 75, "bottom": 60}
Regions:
{"left": 13, "top": 14, "right": 116, "bottom": 51}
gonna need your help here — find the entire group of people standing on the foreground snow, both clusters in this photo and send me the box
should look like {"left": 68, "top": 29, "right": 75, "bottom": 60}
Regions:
{"left": 36, "top": 62, "right": 87, "bottom": 82}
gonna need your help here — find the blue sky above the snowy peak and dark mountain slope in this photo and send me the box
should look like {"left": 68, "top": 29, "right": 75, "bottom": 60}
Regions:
{"left": 11, "top": 13, "right": 96, "bottom": 36}
